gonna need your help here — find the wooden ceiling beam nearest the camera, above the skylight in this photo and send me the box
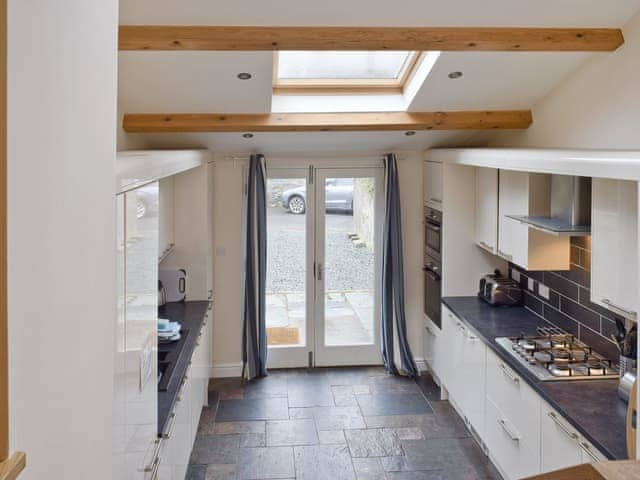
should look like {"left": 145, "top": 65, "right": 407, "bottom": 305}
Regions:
{"left": 119, "top": 25, "right": 624, "bottom": 52}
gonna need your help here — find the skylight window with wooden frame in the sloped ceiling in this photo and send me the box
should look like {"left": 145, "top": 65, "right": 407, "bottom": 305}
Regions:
{"left": 274, "top": 51, "right": 418, "bottom": 93}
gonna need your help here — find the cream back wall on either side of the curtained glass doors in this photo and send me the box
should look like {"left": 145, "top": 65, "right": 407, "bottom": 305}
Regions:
{"left": 213, "top": 152, "right": 423, "bottom": 370}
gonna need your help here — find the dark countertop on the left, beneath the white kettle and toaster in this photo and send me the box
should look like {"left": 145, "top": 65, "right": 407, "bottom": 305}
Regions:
{"left": 158, "top": 301, "right": 209, "bottom": 435}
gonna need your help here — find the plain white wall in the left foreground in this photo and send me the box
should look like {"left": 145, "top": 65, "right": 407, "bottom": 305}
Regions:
{"left": 8, "top": 0, "right": 118, "bottom": 480}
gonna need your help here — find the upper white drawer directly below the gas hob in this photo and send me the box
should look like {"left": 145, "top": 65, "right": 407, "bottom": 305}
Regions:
{"left": 487, "top": 351, "right": 540, "bottom": 438}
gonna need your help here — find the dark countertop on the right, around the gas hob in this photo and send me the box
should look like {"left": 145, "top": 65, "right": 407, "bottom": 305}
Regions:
{"left": 442, "top": 297, "right": 627, "bottom": 460}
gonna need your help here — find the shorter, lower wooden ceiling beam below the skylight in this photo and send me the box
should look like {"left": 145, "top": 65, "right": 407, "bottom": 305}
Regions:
{"left": 123, "top": 110, "right": 532, "bottom": 133}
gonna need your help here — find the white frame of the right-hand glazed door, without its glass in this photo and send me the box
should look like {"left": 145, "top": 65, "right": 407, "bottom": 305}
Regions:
{"left": 313, "top": 167, "right": 384, "bottom": 367}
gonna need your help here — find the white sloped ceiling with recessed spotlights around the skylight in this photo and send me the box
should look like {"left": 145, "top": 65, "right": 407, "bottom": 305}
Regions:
{"left": 118, "top": 0, "right": 640, "bottom": 152}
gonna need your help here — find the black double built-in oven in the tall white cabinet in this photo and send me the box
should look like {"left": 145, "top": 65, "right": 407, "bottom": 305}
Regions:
{"left": 422, "top": 207, "right": 442, "bottom": 328}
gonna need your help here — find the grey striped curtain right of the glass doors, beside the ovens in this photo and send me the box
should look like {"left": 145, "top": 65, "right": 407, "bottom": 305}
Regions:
{"left": 382, "top": 153, "right": 418, "bottom": 377}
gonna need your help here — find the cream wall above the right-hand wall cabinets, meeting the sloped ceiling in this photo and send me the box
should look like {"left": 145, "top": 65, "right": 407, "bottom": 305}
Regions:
{"left": 490, "top": 12, "right": 640, "bottom": 149}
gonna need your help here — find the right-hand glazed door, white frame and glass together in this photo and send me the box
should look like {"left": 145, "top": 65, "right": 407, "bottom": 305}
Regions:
{"left": 315, "top": 168, "right": 383, "bottom": 366}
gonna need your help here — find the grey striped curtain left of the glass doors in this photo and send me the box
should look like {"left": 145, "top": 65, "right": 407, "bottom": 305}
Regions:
{"left": 242, "top": 155, "right": 267, "bottom": 379}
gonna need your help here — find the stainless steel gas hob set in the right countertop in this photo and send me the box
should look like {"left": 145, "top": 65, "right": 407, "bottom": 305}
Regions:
{"left": 496, "top": 327, "right": 618, "bottom": 381}
